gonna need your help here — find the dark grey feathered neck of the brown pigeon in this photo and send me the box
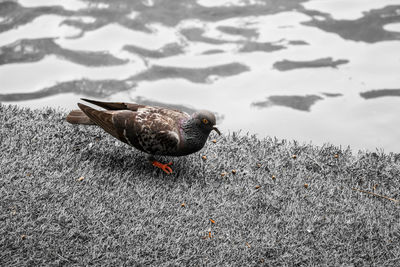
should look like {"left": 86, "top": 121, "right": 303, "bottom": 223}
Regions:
{"left": 181, "top": 118, "right": 208, "bottom": 153}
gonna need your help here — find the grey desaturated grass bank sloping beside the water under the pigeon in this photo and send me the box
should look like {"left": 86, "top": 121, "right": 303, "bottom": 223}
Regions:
{"left": 0, "top": 105, "right": 400, "bottom": 266}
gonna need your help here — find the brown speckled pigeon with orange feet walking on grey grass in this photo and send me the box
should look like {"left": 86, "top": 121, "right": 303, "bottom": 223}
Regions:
{"left": 66, "top": 98, "right": 221, "bottom": 174}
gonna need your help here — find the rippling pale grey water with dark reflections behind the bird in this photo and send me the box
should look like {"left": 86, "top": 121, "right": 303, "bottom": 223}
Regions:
{"left": 0, "top": 0, "right": 400, "bottom": 152}
